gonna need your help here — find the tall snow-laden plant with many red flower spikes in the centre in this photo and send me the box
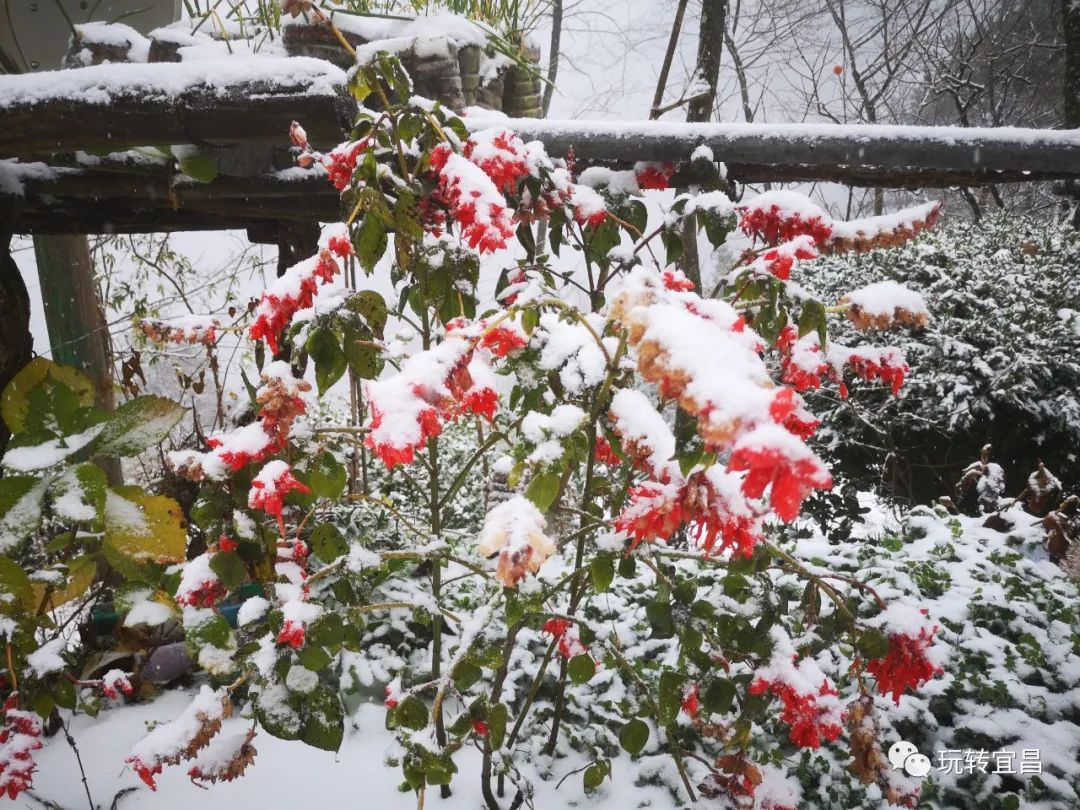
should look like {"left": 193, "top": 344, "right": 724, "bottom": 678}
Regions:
{"left": 0, "top": 54, "right": 942, "bottom": 810}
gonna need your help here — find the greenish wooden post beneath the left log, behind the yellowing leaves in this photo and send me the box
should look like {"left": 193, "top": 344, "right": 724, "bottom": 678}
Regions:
{"left": 33, "top": 234, "right": 123, "bottom": 485}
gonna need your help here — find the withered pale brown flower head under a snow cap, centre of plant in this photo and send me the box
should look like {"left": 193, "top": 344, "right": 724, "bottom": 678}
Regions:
{"left": 477, "top": 495, "right": 555, "bottom": 588}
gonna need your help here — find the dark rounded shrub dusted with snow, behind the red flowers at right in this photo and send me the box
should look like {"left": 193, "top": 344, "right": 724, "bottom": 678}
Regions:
{"left": 802, "top": 216, "right": 1080, "bottom": 502}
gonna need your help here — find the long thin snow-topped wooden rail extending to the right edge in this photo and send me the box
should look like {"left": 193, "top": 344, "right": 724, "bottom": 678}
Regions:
{"left": 479, "top": 117, "right": 1080, "bottom": 187}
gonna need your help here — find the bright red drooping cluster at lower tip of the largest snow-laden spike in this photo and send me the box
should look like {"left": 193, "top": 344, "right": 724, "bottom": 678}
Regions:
{"left": 728, "top": 424, "right": 833, "bottom": 522}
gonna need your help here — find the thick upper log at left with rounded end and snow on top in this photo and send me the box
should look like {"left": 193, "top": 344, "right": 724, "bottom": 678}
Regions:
{"left": 0, "top": 57, "right": 355, "bottom": 158}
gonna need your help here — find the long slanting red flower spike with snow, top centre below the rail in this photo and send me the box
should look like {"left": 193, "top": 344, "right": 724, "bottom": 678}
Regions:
{"left": 431, "top": 144, "right": 514, "bottom": 253}
